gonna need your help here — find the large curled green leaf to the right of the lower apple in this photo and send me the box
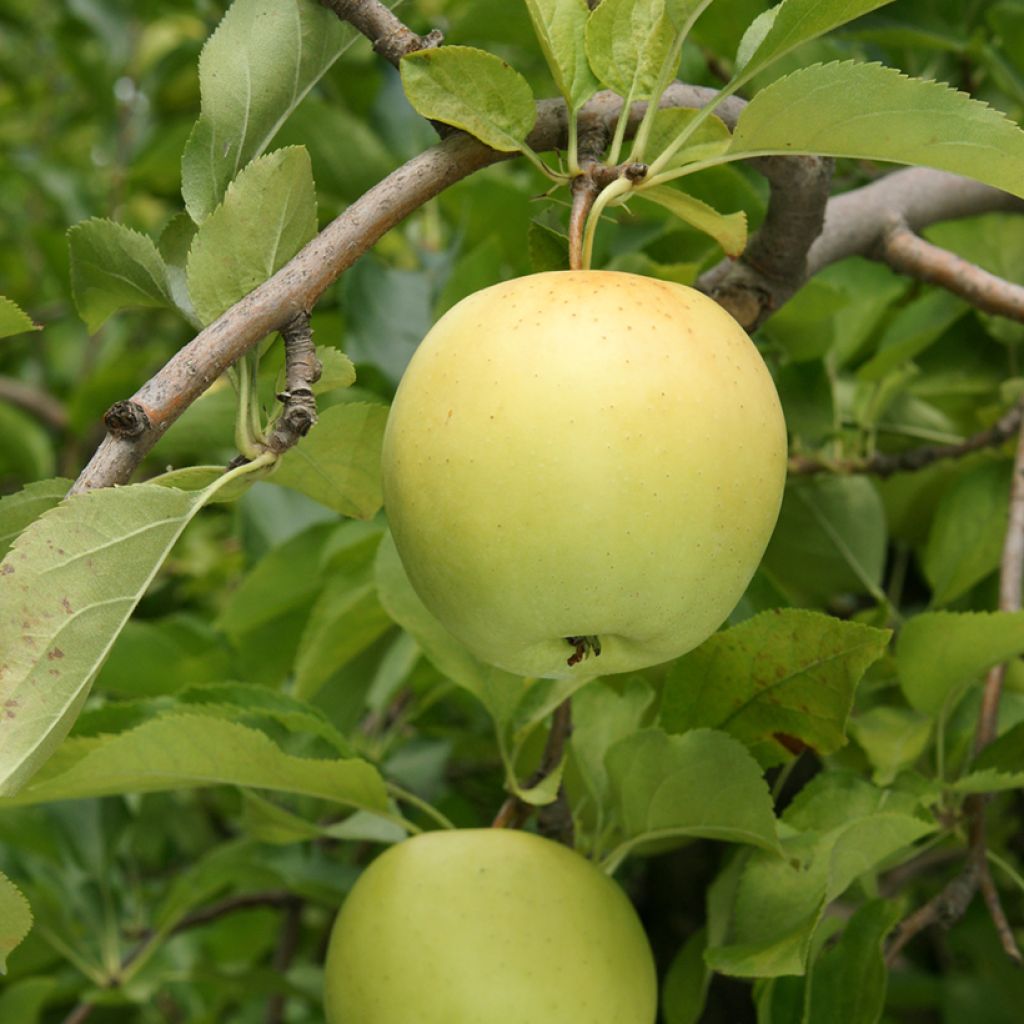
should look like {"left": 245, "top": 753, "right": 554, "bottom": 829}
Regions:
{"left": 706, "top": 775, "right": 934, "bottom": 978}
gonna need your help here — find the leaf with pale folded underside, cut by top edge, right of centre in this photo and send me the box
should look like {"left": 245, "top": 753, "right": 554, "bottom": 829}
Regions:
{"left": 730, "top": 0, "right": 892, "bottom": 85}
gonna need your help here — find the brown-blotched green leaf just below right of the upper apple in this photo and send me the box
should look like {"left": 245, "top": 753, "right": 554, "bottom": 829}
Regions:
{"left": 660, "top": 608, "right": 890, "bottom": 765}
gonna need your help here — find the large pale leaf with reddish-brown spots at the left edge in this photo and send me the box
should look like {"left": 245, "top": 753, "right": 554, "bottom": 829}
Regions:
{"left": 0, "top": 483, "right": 211, "bottom": 796}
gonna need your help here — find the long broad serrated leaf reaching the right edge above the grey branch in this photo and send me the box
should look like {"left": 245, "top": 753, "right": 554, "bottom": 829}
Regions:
{"left": 729, "top": 61, "right": 1024, "bottom": 197}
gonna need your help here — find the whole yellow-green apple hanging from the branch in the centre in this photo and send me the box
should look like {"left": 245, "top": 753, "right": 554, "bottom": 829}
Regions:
{"left": 382, "top": 270, "right": 786, "bottom": 678}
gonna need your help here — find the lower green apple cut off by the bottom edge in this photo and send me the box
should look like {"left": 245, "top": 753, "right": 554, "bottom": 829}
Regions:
{"left": 326, "top": 828, "right": 657, "bottom": 1024}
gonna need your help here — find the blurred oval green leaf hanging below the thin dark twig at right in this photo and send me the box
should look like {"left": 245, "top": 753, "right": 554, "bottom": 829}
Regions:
{"left": 922, "top": 460, "right": 1011, "bottom": 605}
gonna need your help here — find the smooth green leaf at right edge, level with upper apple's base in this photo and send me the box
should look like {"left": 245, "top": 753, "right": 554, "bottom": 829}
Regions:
{"left": 896, "top": 611, "right": 1024, "bottom": 716}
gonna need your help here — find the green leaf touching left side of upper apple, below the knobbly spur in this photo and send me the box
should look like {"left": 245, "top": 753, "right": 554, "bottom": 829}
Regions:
{"left": 271, "top": 402, "right": 387, "bottom": 519}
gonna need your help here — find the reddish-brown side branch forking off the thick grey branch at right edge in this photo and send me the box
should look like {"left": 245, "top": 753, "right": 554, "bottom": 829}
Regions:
{"left": 879, "top": 220, "right": 1024, "bottom": 322}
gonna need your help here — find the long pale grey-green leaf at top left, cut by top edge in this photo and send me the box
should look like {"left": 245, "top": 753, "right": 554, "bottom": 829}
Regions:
{"left": 181, "top": 0, "right": 355, "bottom": 223}
